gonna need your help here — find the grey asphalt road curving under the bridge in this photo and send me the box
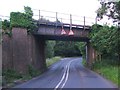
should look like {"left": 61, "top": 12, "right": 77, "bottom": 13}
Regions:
{"left": 14, "top": 58, "right": 116, "bottom": 90}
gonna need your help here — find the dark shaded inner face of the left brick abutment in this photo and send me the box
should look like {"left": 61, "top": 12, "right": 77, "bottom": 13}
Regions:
{"left": 33, "top": 37, "right": 46, "bottom": 72}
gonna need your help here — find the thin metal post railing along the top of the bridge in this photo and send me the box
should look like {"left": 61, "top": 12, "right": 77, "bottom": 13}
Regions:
{"left": 33, "top": 9, "right": 96, "bottom": 27}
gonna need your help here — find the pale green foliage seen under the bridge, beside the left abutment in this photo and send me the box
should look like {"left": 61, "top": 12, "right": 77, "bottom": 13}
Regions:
{"left": 46, "top": 41, "right": 56, "bottom": 58}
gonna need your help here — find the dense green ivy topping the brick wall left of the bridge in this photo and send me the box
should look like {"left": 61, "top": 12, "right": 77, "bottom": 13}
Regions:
{"left": 2, "top": 6, "right": 38, "bottom": 36}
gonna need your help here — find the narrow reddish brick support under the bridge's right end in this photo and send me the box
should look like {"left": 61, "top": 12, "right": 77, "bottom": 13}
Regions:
{"left": 86, "top": 42, "right": 96, "bottom": 68}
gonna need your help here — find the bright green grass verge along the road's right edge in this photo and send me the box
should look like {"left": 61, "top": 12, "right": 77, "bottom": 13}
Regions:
{"left": 93, "top": 60, "right": 120, "bottom": 86}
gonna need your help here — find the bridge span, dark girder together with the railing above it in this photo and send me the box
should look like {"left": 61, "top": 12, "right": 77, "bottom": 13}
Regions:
{"left": 34, "top": 10, "right": 95, "bottom": 41}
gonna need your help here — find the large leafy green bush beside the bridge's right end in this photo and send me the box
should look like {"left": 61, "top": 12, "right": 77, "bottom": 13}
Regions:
{"left": 90, "top": 25, "right": 119, "bottom": 55}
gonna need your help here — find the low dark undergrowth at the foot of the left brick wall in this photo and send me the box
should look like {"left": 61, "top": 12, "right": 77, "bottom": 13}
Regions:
{"left": 2, "top": 65, "right": 41, "bottom": 87}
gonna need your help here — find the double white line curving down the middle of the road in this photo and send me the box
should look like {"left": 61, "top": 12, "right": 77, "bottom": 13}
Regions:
{"left": 54, "top": 60, "right": 75, "bottom": 90}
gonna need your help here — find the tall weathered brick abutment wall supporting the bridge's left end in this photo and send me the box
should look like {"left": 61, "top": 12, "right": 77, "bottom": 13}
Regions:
{"left": 2, "top": 28, "right": 46, "bottom": 74}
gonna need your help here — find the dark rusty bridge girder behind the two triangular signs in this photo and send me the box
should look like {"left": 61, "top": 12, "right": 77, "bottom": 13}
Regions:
{"left": 34, "top": 24, "right": 90, "bottom": 42}
